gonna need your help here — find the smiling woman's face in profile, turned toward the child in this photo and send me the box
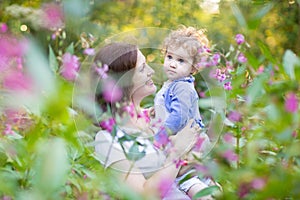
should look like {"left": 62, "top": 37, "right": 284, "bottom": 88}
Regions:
{"left": 131, "top": 50, "right": 156, "bottom": 100}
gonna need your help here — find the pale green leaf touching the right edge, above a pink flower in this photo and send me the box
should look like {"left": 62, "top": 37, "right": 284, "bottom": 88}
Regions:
{"left": 283, "top": 50, "right": 300, "bottom": 80}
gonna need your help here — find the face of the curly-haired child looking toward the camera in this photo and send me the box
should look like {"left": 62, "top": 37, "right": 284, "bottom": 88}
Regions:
{"left": 164, "top": 47, "right": 195, "bottom": 81}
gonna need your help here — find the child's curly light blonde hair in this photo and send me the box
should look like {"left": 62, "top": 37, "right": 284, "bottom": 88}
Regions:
{"left": 163, "top": 25, "right": 210, "bottom": 69}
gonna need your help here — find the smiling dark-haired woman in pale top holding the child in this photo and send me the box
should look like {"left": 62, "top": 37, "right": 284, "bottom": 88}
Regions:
{"left": 94, "top": 43, "right": 202, "bottom": 197}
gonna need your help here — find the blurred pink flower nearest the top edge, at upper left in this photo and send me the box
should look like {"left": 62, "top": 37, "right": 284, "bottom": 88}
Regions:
{"left": 42, "top": 3, "right": 64, "bottom": 30}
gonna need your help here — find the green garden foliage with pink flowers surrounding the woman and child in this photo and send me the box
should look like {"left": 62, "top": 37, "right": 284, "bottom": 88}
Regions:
{"left": 0, "top": 0, "right": 300, "bottom": 199}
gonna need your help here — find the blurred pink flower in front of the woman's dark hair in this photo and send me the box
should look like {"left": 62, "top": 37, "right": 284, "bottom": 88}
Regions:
{"left": 102, "top": 79, "right": 123, "bottom": 103}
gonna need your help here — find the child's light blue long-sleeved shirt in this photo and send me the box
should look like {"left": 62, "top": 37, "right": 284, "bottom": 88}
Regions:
{"left": 157, "top": 76, "right": 204, "bottom": 134}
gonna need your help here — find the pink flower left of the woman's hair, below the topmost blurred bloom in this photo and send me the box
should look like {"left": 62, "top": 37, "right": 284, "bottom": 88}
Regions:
{"left": 61, "top": 52, "right": 80, "bottom": 81}
